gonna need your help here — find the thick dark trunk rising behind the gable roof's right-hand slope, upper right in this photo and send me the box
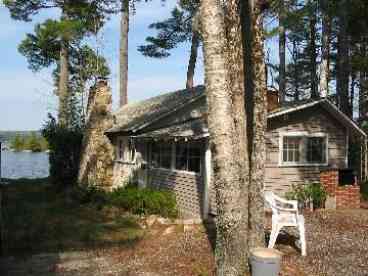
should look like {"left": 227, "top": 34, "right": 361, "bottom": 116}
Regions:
{"left": 336, "top": 0, "right": 350, "bottom": 116}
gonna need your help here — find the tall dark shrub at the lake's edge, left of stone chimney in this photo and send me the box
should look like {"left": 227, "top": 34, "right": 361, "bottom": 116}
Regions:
{"left": 42, "top": 115, "right": 83, "bottom": 187}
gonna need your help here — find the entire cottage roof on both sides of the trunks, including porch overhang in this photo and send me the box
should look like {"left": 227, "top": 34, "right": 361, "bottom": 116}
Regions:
{"left": 106, "top": 86, "right": 367, "bottom": 138}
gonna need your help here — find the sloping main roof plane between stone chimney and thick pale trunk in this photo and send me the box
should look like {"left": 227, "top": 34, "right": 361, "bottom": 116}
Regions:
{"left": 107, "top": 86, "right": 205, "bottom": 133}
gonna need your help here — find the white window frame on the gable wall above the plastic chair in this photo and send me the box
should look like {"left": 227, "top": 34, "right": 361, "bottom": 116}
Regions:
{"left": 279, "top": 131, "right": 329, "bottom": 167}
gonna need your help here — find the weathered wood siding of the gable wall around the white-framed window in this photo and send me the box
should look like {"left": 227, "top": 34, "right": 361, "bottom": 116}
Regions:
{"left": 265, "top": 107, "right": 347, "bottom": 194}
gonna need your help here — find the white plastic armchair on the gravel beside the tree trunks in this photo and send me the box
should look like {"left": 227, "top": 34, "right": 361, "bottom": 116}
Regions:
{"left": 265, "top": 191, "right": 307, "bottom": 256}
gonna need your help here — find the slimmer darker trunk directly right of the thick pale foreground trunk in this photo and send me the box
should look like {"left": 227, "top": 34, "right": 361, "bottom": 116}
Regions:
{"left": 247, "top": 0, "right": 267, "bottom": 248}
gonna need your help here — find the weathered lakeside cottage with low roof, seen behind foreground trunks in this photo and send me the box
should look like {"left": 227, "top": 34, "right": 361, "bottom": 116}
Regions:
{"left": 106, "top": 86, "right": 366, "bottom": 218}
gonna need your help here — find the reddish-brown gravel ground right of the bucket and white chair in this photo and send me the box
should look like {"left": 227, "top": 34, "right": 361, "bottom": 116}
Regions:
{"left": 277, "top": 209, "right": 368, "bottom": 276}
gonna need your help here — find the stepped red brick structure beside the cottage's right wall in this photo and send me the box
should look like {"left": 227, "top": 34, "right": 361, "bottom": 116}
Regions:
{"left": 320, "top": 169, "right": 360, "bottom": 209}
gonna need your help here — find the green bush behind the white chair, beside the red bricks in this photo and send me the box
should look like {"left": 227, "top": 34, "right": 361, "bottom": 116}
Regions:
{"left": 286, "top": 182, "right": 327, "bottom": 208}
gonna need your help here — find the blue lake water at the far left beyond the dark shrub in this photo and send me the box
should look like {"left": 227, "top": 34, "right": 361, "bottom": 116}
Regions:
{"left": 1, "top": 151, "right": 49, "bottom": 179}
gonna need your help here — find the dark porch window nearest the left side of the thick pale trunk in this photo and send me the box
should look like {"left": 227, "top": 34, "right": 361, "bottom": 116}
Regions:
{"left": 175, "top": 143, "right": 201, "bottom": 173}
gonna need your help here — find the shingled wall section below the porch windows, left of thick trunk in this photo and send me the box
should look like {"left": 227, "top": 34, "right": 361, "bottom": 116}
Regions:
{"left": 148, "top": 169, "right": 204, "bottom": 218}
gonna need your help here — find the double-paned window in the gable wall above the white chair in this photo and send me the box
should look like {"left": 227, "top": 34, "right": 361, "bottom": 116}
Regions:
{"left": 281, "top": 134, "right": 327, "bottom": 165}
